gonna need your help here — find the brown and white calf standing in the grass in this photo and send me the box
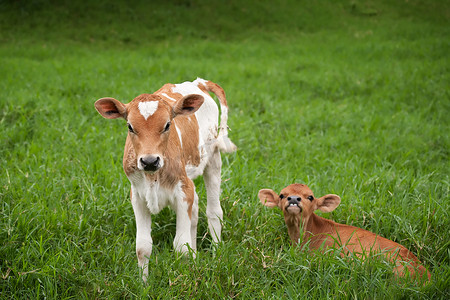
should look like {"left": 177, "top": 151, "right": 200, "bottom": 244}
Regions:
{"left": 95, "top": 78, "right": 236, "bottom": 280}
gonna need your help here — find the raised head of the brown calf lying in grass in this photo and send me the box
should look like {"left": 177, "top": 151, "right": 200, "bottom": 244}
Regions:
{"left": 258, "top": 183, "right": 341, "bottom": 226}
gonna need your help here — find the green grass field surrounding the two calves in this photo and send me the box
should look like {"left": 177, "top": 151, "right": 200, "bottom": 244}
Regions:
{"left": 0, "top": 0, "right": 450, "bottom": 299}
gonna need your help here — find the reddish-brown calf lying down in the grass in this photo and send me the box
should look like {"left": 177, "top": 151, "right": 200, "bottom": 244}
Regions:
{"left": 258, "top": 184, "right": 431, "bottom": 280}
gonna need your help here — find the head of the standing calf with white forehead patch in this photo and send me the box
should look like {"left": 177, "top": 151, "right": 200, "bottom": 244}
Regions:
{"left": 95, "top": 94, "right": 204, "bottom": 173}
